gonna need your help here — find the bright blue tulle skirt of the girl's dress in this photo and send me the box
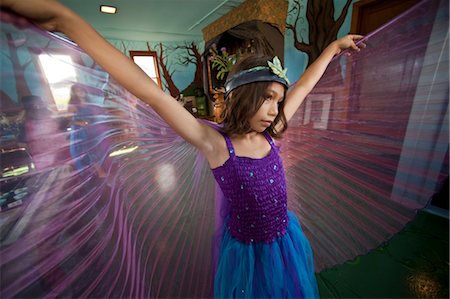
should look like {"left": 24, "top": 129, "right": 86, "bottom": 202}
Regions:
{"left": 214, "top": 212, "right": 319, "bottom": 298}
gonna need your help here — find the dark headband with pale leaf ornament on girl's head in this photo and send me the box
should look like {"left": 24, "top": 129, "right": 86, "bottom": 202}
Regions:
{"left": 225, "top": 56, "right": 290, "bottom": 94}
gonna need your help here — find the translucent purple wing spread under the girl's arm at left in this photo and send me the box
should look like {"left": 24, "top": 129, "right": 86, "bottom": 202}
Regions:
{"left": 0, "top": 13, "right": 215, "bottom": 298}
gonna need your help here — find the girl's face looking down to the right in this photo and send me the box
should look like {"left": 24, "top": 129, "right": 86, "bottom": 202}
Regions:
{"left": 249, "top": 82, "right": 284, "bottom": 133}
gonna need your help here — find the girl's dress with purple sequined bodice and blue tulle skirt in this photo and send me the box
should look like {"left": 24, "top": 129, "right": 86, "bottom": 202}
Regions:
{"left": 212, "top": 132, "right": 318, "bottom": 298}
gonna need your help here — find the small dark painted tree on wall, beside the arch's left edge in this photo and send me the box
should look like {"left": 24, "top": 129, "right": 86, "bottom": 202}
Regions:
{"left": 175, "top": 42, "right": 203, "bottom": 94}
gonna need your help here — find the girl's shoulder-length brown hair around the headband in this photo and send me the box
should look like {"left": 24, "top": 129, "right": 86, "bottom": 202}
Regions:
{"left": 222, "top": 55, "right": 287, "bottom": 138}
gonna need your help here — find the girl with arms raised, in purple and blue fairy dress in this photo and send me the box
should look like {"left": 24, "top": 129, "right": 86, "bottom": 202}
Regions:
{"left": 0, "top": 0, "right": 361, "bottom": 298}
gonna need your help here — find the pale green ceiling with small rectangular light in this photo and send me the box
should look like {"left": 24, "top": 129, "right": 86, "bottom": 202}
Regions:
{"left": 60, "top": 0, "right": 246, "bottom": 42}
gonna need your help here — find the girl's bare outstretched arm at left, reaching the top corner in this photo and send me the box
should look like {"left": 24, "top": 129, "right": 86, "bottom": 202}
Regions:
{"left": 0, "top": 0, "right": 223, "bottom": 160}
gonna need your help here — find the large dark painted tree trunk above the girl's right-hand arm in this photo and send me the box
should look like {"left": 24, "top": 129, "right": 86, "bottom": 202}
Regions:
{"left": 286, "top": 0, "right": 352, "bottom": 66}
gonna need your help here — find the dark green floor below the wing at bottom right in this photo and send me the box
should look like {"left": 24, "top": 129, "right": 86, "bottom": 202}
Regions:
{"left": 317, "top": 210, "right": 449, "bottom": 298}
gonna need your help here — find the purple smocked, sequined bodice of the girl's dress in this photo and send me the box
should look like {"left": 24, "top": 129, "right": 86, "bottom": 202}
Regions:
{"left": 212, "top": 132, "right": 288, "bottom": 244}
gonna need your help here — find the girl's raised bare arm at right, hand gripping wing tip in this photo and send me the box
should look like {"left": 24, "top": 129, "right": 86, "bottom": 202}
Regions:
{"left": 284, "top": 35, "right": 364, "bottom": 121}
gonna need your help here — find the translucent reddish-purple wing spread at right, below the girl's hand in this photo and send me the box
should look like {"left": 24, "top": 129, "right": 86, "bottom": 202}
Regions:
{"left": 281, "top": 1, "right": 449, "bottom": 271}
